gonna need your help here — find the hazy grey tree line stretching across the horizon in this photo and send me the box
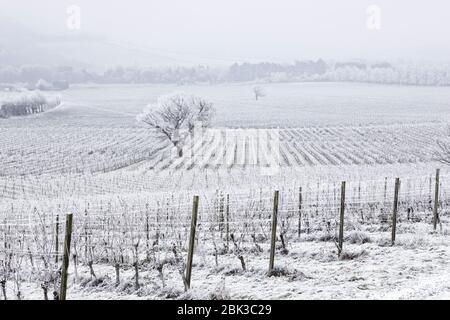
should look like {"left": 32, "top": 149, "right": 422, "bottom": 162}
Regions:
{"left": 0, "top": 59, "right": 450, "bottom": 87}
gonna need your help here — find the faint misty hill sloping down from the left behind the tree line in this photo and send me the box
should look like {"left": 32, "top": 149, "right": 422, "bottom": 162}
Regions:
{"left": 0, "top": 16, "right": 199, "bottom": 70}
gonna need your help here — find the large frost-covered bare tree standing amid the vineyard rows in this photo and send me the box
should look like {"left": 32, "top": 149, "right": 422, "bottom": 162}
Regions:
{"left": 137, "top": 93, "right": 214, "bottom": 157}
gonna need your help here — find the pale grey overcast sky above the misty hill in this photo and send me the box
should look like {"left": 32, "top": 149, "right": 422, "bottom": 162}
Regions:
{"left": 0, "top": 0, "right": 450, "bottom": 65}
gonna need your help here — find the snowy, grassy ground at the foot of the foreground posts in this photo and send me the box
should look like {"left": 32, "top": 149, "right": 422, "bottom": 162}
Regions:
{"left": 8, "top": 223, "right": 450, "bottom": 300}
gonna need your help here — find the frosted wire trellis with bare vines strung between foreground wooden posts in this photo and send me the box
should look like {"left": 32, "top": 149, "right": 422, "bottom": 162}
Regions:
{"left": 0, "top": 170, "right": 450, "bottom": 298}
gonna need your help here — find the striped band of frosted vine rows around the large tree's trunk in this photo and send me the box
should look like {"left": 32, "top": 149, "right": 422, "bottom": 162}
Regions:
{"left": 0, "top": 122, "right": 447, "bottom": 179}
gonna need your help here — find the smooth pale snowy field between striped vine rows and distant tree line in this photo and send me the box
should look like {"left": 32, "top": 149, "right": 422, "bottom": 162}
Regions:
{"left": 3, "top": 83, "right": 450, "bottom": 128}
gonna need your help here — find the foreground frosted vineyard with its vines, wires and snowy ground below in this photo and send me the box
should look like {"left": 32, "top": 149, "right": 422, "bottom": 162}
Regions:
{"left": 0, "top": 171, "right": 450, "bottom": 299}
